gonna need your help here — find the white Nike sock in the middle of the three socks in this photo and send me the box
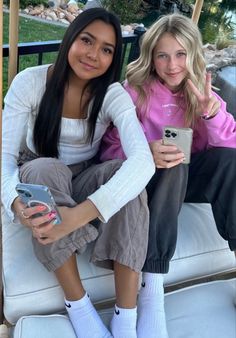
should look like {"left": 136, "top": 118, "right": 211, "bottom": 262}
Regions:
{"left": 110, "top": 305, "right": 137, "bottom": 338}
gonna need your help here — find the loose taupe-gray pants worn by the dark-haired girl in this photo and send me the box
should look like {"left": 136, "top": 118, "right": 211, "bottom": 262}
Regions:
{"left": 19, "top": 152, "right": 149, "bottom": 272}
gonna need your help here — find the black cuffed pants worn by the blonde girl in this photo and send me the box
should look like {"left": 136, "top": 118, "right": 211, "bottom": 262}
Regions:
{"left": 143, "top": 148, "right": 236, "bottom": 273}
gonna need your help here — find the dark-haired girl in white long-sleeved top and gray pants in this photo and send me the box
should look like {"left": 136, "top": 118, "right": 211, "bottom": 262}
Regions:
{"left": 2, "top": 8, "right": 154, "bottom": 338}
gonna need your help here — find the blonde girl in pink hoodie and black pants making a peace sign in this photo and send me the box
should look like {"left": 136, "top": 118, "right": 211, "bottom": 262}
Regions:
{"left": 101, "top": 14, "right": 236, "bottom": 338}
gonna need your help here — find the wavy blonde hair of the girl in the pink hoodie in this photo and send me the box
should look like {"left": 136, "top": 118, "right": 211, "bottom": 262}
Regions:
{"left": 126, "top": 14, "right": 206, "bottom": 127}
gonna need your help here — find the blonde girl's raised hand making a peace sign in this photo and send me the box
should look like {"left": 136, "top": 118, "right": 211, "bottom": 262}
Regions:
{"left": 187, "top": 73, "right": 220, "bottom": 120}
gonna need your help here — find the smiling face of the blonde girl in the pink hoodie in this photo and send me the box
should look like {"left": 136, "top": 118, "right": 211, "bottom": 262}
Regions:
{"left": 153, "top": 33, "right": 188, "bottom": 92}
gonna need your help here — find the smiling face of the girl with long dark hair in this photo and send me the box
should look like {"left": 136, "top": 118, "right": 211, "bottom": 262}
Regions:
{"left": 68, "top": 20, "right": 116, "bottom": 84}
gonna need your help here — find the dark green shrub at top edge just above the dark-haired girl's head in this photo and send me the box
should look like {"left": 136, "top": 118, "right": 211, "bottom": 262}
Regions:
{"left": 101, "top": 0, "right": 142, "bottom": 24}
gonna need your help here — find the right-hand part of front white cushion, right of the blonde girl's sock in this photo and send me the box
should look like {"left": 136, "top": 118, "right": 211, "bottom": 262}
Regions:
{"left": 165, "top": 279, "right": 236, "bottom": 338}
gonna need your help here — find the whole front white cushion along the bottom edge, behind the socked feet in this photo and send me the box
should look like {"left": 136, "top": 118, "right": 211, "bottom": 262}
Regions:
{"left": 14, "top": 279, "right": 236, "bottom": 338}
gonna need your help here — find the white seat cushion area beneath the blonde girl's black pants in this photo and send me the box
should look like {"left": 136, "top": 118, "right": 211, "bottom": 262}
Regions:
{"left": 165, "top": 203, "right": 236, "bottom": 285}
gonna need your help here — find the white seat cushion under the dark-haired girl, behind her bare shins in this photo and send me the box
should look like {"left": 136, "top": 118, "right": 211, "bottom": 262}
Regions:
{"left": 2, "top": 207, "right": 115, "bottom": 324}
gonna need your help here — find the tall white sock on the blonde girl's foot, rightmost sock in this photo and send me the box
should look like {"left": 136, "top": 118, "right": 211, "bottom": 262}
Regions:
{"left": 137, "top": 272, "right": 168, "bottom": 338}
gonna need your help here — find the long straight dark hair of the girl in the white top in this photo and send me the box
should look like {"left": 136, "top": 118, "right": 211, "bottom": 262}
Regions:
{"left": 33, "top": 8, "right": 122, "bottom": 158}
